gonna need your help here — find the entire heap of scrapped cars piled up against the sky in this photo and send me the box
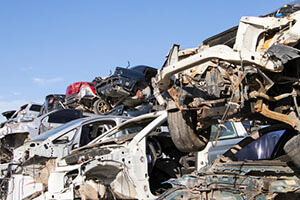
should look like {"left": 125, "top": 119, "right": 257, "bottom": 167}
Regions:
{"left": 0, "top": 4, "right": 300, "bottom": 200}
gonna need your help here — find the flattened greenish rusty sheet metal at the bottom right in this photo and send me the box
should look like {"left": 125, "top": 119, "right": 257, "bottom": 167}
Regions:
{"left": 160, "top": 174, "right": 300, "bottom": 200}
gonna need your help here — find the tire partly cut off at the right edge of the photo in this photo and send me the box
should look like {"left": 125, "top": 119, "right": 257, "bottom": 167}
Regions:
{"left": 283, "top": 135, "right": 300, "bottom": 168}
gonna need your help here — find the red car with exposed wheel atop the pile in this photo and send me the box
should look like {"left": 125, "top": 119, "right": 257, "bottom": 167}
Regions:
{"left": 65, "top": 82, "right": 110, "bottom": 114}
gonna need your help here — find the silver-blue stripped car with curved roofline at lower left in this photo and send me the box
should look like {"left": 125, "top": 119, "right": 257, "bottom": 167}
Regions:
{"left": 3, "top": 115, "right": 129, "bottom": 199}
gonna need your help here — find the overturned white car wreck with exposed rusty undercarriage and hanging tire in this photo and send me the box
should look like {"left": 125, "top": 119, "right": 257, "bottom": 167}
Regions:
{"left": 152, "top": 4, "right": 300, "bottom": 152}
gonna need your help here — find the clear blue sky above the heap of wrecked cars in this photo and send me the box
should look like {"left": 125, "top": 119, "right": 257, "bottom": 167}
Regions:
{"left": 0, "top": 0, "right": 291, "bottom": 121}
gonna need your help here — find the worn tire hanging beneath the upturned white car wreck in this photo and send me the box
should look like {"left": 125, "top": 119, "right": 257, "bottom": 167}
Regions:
{"left": 168, "top": 111, "right": 207, "bottom": 152}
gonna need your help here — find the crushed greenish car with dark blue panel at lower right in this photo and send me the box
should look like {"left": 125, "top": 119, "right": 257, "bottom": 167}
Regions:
{"left": 158, "top": 124, "right": 300, "bottom": 200}
